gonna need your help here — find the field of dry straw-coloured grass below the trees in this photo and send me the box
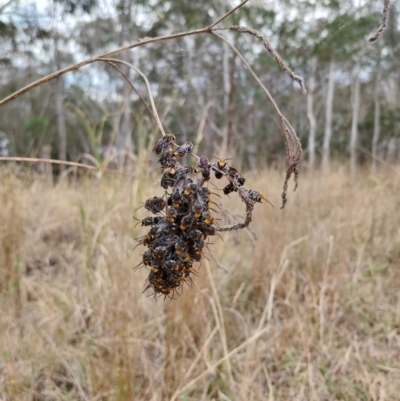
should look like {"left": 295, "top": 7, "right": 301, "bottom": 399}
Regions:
{"left": 0, "top": 167, "right": 400, "bottom": 401}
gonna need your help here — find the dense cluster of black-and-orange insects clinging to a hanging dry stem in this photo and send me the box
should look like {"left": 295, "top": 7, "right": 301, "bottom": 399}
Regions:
{"left": 136, "top": 134, "right": 265, "bottom": 298}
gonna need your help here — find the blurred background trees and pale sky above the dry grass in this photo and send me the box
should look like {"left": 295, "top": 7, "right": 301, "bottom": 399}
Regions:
{"left": 0, "top": 0, "right": 400, "bottom": 168}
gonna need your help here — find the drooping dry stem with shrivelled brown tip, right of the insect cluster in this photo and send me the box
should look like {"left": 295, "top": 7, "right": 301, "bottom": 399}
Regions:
{"left": 213, "top": 32, "right": 303, "bottom": 209}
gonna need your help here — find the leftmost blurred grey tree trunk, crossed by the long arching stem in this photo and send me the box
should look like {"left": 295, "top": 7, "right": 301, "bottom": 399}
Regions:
{"left": 54, "top": 38, "right": 67, "bottom": 172}
